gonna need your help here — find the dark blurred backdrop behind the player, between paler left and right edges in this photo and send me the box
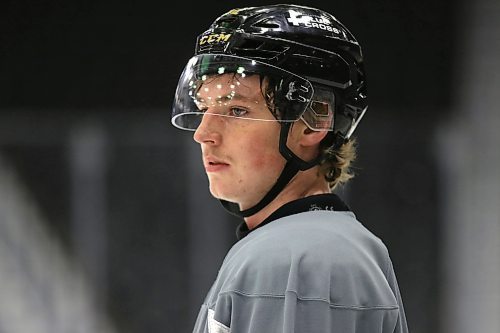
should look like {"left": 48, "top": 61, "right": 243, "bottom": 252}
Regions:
{"left": 0, "top": 0, "right": 459, "bottom": 333}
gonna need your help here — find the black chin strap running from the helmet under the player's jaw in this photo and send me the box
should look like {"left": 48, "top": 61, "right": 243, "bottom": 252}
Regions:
{"left": 219, "top": 123, "right": 320, "bottom": 218}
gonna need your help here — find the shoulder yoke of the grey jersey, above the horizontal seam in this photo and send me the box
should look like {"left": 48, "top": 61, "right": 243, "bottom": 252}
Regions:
{"left": 217, "top": 211, "right": 397, "bottom": 307}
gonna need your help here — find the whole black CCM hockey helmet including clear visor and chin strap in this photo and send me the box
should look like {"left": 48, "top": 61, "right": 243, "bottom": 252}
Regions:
{"left": 172, "top": 5, "right": 367, "bottom": 216}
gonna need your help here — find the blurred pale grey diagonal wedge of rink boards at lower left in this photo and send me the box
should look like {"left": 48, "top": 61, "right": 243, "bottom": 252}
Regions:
{"left": 0, "top": 155, "right": 116, "bottom": 333}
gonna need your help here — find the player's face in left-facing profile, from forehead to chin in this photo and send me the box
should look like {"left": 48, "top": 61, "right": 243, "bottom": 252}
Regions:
{"left": 194, "top": 74, "right": 285, "bottom": 209}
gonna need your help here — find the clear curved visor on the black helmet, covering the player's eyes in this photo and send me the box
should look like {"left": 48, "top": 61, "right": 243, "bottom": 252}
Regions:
{"left": 172, "top": 54, "right": 313, "bottom": 130}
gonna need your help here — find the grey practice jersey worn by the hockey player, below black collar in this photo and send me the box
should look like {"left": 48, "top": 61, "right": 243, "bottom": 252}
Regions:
{"left": 193, "top": 211, "right": 408, "bottom": 333}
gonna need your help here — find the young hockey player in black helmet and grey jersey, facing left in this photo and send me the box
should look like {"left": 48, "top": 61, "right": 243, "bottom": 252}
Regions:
{"left": 172, "top": 5, "right": 407, "bottom": 333}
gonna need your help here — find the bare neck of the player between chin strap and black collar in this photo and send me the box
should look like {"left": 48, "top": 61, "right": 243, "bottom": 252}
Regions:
{"left": 245, "top": 167, "right": 330, "bottom": 229}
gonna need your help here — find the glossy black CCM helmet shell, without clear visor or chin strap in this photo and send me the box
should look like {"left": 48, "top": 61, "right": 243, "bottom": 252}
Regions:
{"left": 173, "top": 5, "right": 367, "bottom": 145}
